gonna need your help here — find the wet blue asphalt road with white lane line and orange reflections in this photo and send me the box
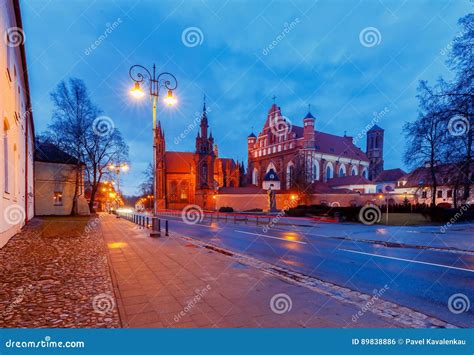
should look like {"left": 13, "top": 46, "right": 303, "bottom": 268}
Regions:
{"left": 158, "top": 217, "right": 474, "bottom": 327}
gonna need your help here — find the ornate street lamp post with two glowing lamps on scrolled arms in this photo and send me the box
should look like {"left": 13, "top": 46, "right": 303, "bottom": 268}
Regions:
{"left": 129, "top": 64, "right": 178, "bottom": 216}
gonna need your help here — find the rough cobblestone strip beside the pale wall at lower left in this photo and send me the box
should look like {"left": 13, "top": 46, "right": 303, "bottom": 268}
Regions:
{"left": 0, "top": 217, "right": 120, "bottom": 328}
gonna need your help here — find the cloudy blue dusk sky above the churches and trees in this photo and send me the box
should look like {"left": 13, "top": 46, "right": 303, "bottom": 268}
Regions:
{"left": 21, "top": 0, "right": 474, "bottom": 194}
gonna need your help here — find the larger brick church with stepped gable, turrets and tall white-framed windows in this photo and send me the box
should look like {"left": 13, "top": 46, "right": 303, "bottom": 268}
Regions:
{"left": 247, "top": 104, "right": 384, "bottom": 193}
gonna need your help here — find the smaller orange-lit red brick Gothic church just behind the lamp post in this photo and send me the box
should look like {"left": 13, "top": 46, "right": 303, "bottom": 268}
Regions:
{"left": 154, "top": 103, "right": 244, "bottom": 209}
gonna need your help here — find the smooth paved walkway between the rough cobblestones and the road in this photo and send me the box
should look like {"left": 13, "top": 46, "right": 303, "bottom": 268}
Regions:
{"left": 101, "top": 216, "right": 403, "bottom": 328}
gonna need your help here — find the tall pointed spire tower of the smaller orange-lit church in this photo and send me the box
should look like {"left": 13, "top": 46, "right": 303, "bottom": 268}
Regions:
{"left": 195, "top": 101, "right": 216, "bottom": 209}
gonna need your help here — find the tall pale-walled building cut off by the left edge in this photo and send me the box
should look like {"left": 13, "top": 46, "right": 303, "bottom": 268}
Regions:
{"left": 0, "top": 0, "right": 34, "bottom": 247}
